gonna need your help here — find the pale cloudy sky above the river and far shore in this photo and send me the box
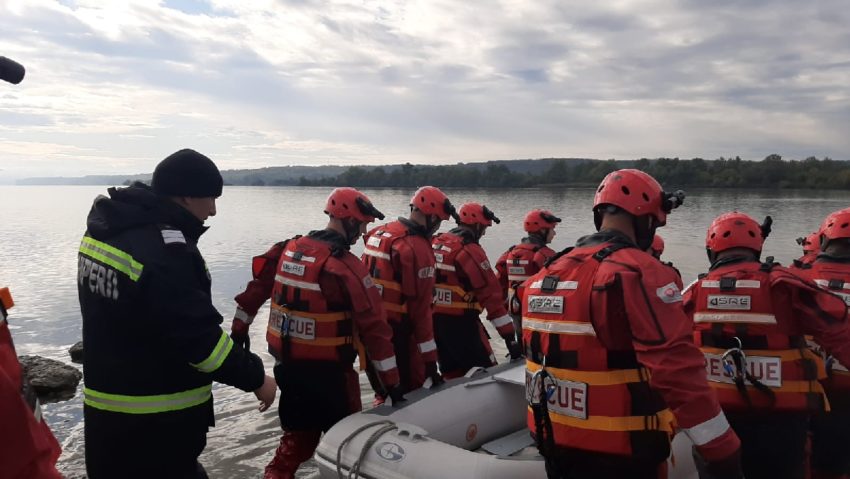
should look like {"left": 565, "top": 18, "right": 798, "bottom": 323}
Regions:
{"left": 0, "top": 0, "right": 850, "bottom": 180}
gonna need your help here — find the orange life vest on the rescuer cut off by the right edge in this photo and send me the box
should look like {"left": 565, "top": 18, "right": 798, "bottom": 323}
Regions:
{"left": 804, "top": 261, "right": 850, "bottom": 394}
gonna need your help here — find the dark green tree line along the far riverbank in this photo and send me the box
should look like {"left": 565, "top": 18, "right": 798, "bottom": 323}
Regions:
{"left": 298, "top": 154, "right": 850, "bottom": 189}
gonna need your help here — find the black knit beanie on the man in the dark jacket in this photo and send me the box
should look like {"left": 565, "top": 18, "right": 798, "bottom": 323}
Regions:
{"left": 151, "top": 148, "right": 224, "bottom": 198}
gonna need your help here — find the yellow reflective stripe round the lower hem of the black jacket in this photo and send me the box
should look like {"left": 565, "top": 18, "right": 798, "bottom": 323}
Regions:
{"left": 83, "top": 384, "right": 212, "bottom": 414}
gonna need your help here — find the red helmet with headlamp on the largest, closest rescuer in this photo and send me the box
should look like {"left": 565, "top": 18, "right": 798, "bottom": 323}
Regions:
{"left": 593, "top": 169, "right": 685, "bottom": 226}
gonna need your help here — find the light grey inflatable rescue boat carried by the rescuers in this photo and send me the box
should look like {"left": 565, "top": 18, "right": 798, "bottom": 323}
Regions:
{"left": 314, "top": 360, "right": 696, "bottom": 479}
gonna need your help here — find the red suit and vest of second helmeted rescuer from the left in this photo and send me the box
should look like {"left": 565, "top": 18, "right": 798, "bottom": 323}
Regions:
{"left": 361, "top": 218, "right": 437, "bottom": 392}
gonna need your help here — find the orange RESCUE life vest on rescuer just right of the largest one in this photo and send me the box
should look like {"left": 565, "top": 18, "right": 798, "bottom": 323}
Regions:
{"left": 693, "top": 262, "right": 828, "bottom": 411}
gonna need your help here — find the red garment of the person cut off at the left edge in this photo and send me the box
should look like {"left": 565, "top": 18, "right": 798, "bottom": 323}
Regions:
{"left": 0, "top": 288, "right": 62, "bottom": 479}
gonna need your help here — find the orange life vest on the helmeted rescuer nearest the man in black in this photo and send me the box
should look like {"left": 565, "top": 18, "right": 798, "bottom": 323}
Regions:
{"left": 266, "top": 236, "right": 355, "bottom": 364}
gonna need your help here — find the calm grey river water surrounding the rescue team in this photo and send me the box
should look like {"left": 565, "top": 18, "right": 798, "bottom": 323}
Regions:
{"left": 0, "top": 186, "right": 850, "bottom": 478}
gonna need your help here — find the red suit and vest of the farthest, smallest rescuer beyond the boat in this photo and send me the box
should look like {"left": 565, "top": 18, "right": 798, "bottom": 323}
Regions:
{"left": 496, "top": 235, "right": 555, "bottom": 315}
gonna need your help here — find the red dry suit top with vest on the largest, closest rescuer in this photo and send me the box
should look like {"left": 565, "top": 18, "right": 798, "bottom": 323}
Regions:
{"left": 521, "top": 231, "right": 740, "bottom": 476}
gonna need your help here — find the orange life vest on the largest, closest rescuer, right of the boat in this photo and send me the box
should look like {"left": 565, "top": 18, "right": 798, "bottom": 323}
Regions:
{"left": 522, "top": 244, "right": 674, "bottom": 461}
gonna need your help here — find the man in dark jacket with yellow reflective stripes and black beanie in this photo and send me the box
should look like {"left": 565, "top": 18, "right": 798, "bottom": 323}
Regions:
{"left": 77, "top": 149, "right": 277, "bottom": 479}
